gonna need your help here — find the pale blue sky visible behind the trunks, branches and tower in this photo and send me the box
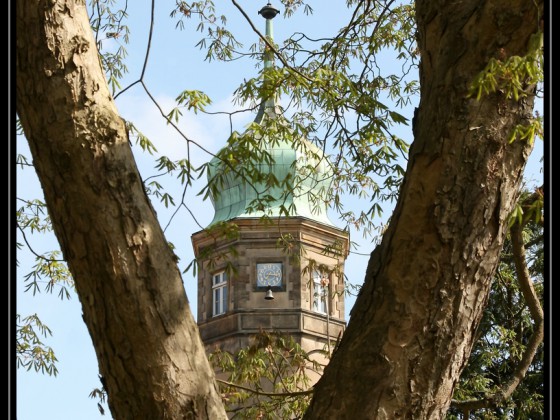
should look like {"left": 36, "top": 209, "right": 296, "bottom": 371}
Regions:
{"left": 16, "top": 0, "right": 542, "bottom": 420}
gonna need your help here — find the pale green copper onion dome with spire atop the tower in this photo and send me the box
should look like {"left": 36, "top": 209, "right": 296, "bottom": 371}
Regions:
{"left": 208, "top": 3, "right": 334, "bottom": 226}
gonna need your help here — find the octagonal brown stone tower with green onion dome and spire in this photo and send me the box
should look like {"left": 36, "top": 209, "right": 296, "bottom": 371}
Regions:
{"left": 192, "top": 3, "right": 349, "bottom": 360}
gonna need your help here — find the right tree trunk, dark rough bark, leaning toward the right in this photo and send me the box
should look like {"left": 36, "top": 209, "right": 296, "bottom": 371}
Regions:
{"left": 305, "top": 0, "right": 542, "bottom": 419}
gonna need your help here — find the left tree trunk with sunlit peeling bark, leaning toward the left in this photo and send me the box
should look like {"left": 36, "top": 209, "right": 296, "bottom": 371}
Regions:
{"left": 16, "top": 0, "right": 227, "bottom": 420}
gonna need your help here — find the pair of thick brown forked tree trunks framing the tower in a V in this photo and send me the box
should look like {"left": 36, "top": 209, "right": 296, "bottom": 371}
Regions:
{"left": 16, "top": 0, "right": 542, "bottom": 419}
